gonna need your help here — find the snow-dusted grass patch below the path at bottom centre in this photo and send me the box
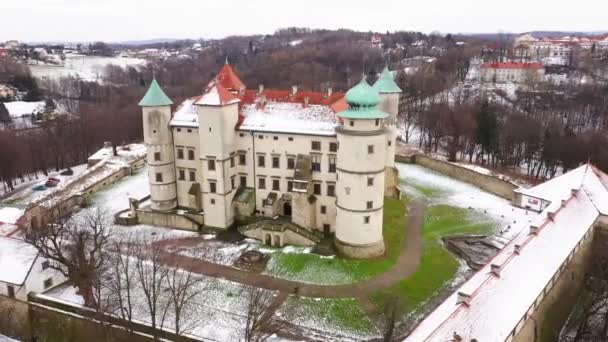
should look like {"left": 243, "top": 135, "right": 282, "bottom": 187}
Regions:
{"left": 279, "top": 296, "right": 377, "bottom": 337}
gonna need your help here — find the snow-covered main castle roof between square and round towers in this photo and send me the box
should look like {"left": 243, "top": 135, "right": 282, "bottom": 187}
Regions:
{"left": 240, "top": 102, "right": 338, "bottom": 136}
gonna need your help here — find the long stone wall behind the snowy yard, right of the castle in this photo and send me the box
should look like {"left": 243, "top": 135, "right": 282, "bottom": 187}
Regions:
{"left": 414, "top": 154, "right": 518, "bottom": 201}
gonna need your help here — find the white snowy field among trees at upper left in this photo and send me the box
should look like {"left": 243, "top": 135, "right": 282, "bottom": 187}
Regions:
{"left": 29, "top": 55, "right": 146, "bottom": 81}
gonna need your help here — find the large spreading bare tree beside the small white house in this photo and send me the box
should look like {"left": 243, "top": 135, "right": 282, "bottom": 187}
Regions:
{"left": 26, "top": 209, "right": 110, "bottom": 309}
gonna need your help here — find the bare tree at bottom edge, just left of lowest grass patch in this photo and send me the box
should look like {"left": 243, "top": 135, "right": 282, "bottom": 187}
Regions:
{"left": 245, "top": 287, "right": 281, "bottom": 342}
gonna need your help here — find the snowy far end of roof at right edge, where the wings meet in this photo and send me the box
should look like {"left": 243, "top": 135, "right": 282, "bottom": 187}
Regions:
{"left": 515, "top": 164, "right": 608, "bottom": 215}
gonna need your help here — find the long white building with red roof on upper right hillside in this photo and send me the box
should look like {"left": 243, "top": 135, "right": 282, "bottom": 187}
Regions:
{"left": 480, "top": 62, "right": 545, "bottom": 83}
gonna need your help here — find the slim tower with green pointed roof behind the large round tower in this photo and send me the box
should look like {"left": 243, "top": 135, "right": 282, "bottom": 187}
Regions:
{"left": 373, "top": 67, "right": 401, "bottom": 197}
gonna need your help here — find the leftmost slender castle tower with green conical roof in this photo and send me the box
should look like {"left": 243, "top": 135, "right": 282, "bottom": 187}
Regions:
{"left": 139, "top": 79, "right": 177, "bottom": 211}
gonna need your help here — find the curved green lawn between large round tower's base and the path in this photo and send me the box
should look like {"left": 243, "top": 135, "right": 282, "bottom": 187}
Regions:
{"left": 265, "top": 199, "right": 407, "bottom": 284}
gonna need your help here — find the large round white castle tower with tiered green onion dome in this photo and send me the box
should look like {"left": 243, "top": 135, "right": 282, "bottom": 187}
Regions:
{"left": 335, "top": 79, "right": 389, "bottom": 258}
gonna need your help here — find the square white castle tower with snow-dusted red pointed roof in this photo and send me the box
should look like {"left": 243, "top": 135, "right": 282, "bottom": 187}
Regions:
{"left": 194, "top": 80, "right": 240, "bottom": 228}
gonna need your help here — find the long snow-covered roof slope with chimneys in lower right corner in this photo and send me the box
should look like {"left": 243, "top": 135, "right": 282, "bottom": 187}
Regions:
{"left": 406, "top": 191, "right": 599, "bottom": 341}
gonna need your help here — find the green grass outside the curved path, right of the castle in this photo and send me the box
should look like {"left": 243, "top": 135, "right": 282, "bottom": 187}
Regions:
{"left": 371, "top": 205, "right": 495, "bottom": 312}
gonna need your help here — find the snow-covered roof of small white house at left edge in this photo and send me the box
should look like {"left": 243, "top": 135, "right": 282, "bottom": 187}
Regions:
{"left": 0, "top": 237, "right": 38, "bottom": 285}
